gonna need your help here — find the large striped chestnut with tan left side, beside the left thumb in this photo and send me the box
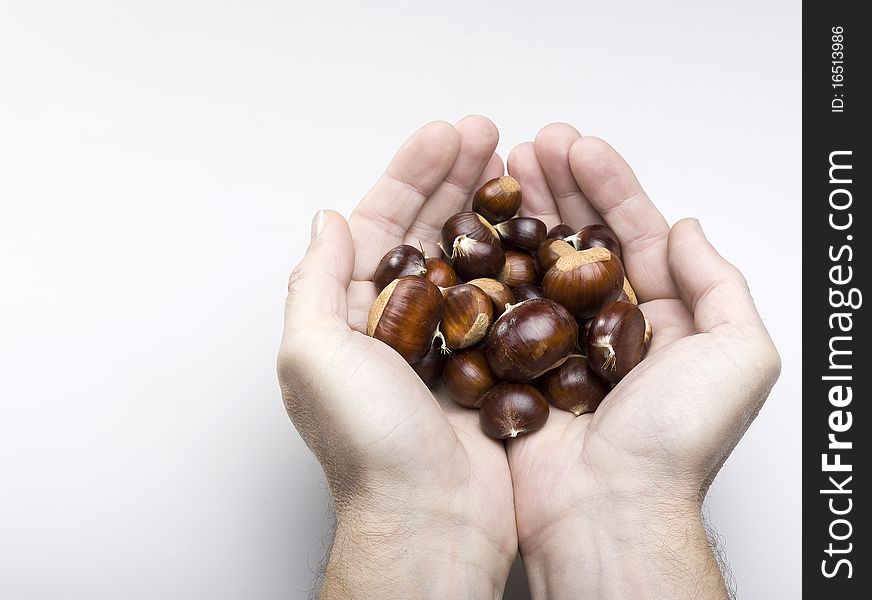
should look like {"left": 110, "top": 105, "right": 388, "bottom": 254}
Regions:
{"left": 366, "top": 275, "right": 443, "bottom": 363}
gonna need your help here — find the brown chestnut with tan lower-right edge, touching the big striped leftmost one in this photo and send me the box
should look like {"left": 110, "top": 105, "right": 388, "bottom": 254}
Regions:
{"left": 439, "top": 283, "right": 494, "bottom": 350}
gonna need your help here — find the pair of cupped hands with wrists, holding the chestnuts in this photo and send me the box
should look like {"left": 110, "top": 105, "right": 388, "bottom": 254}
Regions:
{"left": 278, "top": 116, "right": 780, "bottom": 599}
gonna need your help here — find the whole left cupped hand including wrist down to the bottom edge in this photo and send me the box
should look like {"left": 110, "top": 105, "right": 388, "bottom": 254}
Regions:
{"left": 278, "top": 117, "right": 517, "bottom": 599}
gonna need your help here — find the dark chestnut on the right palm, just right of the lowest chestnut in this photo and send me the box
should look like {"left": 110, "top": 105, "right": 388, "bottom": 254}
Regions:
{"left": 539, "top": 354, "right": 611, "bottom": 417}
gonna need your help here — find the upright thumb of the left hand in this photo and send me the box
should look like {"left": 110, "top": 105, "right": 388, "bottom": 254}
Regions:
{"left": 285, "top": 210, "right": 354, "bottom": 340}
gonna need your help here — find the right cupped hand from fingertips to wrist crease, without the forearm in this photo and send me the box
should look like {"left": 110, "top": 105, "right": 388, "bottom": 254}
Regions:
{"left": 500, "top": 125, "right": 779, "bottom": 552}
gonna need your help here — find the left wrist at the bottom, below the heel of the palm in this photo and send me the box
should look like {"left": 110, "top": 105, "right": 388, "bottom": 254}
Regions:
{"left": 321, "top": 507, "right": 515, "bottom": 600}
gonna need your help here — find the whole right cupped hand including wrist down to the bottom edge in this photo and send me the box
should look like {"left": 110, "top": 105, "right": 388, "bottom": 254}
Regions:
{"left": 508, "top": 124, "right": 780, "bottom": 598}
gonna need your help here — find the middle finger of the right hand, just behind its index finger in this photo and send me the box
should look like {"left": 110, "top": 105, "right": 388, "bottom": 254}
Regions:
{"left": 534, "top": 123, "right": 602, "bottom": 229}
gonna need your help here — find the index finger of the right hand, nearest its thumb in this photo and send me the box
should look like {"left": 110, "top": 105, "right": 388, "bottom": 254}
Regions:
{"left": 569, "top": 137, "right": 678, "bottom": 301}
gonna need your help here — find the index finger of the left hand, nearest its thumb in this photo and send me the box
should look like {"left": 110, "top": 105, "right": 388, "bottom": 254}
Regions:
{"left": 349, "top": 121, "right": 460, "bottom": 281}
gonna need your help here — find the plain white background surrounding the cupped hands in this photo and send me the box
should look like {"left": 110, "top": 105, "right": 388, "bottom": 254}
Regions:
{"left": 0, "top": 0, "right": 801, "bottom": 600}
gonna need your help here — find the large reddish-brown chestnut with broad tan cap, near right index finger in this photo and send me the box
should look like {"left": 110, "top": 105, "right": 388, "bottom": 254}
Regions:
{"left": 542, "top": 248, "right": 624, "bottom": 321}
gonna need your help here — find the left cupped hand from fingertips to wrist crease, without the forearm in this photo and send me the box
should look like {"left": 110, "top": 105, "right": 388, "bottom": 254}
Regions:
{"left": 279, "top": 117, "right": 517, "bottom": 563}
